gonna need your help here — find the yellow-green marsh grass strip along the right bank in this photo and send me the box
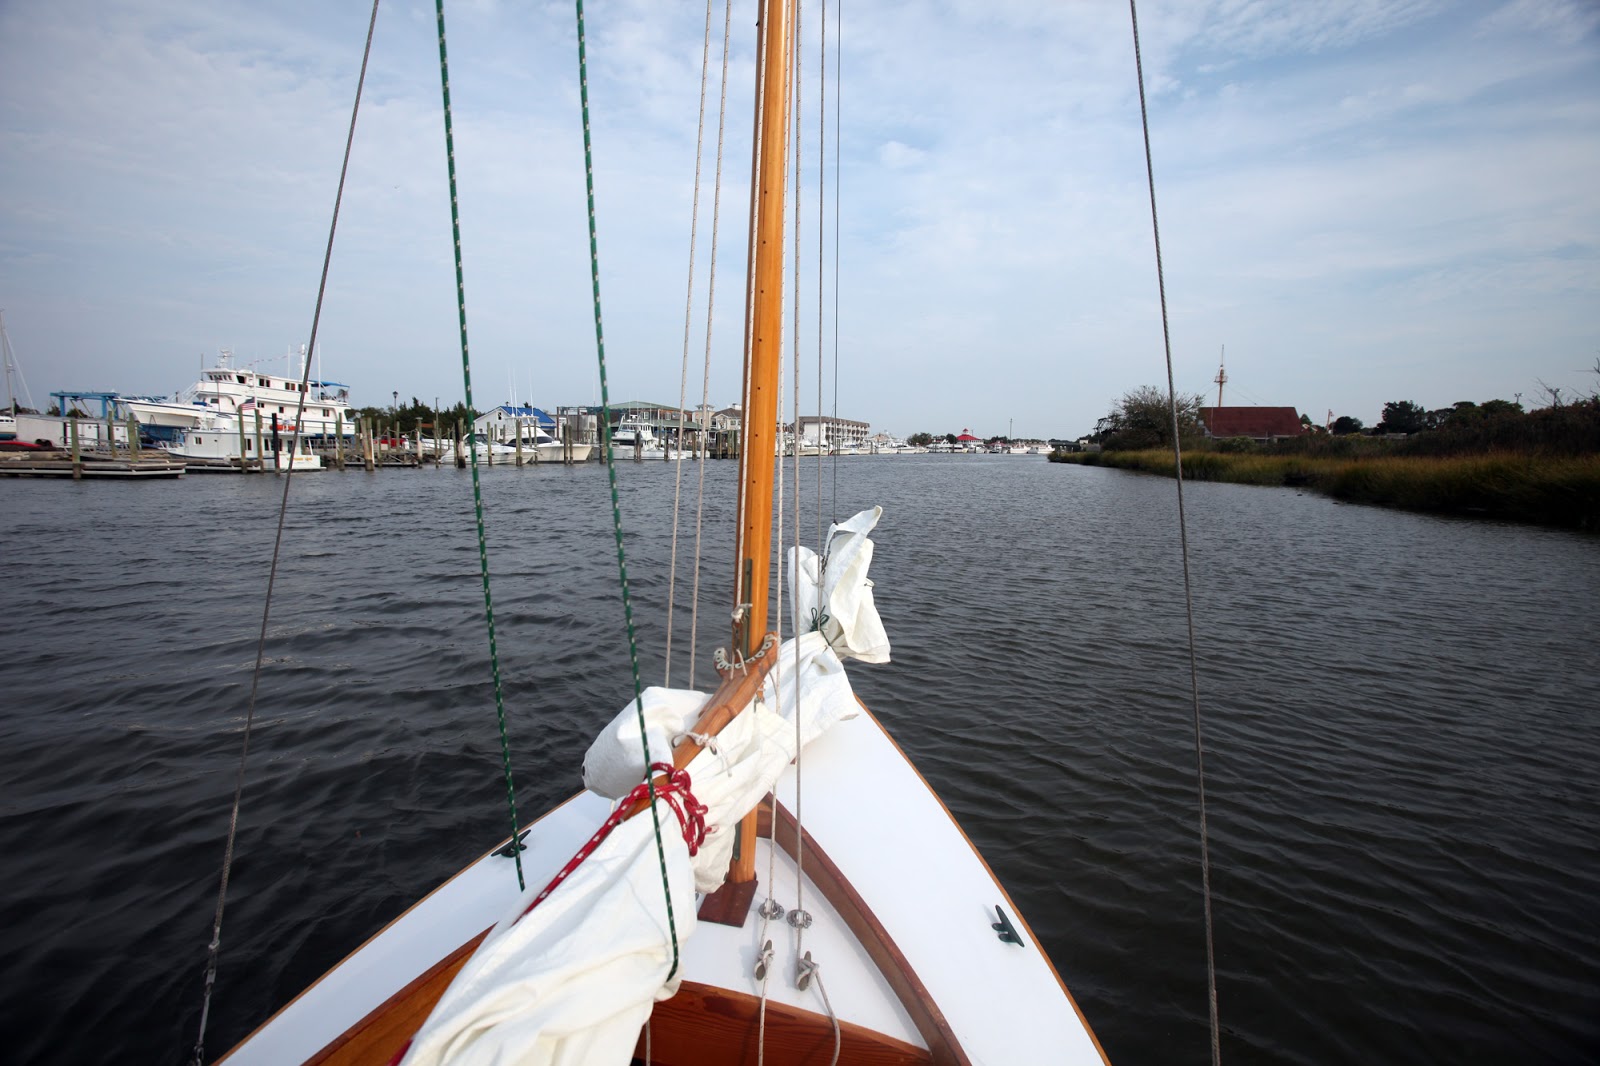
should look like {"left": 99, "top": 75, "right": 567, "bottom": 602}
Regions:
{"left": 1050, "top": 450, "right": 1600, "bottom": 530}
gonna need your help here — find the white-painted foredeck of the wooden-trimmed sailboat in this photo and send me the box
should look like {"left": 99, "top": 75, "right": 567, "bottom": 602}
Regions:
{"left": 226, "top": 701, "right": 1104, "bottom": 1066}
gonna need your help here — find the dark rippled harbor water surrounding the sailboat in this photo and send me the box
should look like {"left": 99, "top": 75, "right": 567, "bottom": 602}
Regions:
{"left": 0, "top": 456, "right": 1600, "bottom": 1066}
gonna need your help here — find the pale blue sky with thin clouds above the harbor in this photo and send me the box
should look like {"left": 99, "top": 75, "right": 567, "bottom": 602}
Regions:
{"left": 0, "top": 0, "right": 1600, "bottom": 437}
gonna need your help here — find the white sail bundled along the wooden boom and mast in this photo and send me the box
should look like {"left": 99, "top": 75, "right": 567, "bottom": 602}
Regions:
{"left": 403, "top": 507, "right": 888, "bottom": 1066}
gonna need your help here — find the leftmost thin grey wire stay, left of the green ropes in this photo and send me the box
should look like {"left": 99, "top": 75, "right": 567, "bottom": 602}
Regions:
{"left": 188, "top": 0, "right": 379, "bottom": 1066}
